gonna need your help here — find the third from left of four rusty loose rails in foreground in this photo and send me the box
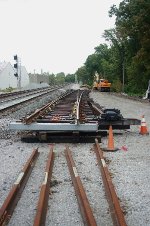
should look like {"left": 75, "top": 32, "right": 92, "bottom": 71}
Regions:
{"left": 65, "top": 147, "right": 97, "bottom": 226}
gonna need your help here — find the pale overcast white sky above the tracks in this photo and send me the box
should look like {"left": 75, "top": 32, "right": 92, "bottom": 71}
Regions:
{"left": 0, "top": 0, "right": 121, "bottom": 74}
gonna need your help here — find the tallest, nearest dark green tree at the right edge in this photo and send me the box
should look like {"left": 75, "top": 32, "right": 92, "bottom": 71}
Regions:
{"left": 109, "top": 0, "right": 150, "bottom": 93}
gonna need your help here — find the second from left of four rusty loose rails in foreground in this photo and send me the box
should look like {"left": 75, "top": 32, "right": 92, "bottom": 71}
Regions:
{"left": 34, "top": 146, "right": 54, "bottom": 226}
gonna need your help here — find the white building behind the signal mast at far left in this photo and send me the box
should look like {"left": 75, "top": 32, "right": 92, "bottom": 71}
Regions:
{"left": 0, "top": 61, "right": 29, "bottom": 89}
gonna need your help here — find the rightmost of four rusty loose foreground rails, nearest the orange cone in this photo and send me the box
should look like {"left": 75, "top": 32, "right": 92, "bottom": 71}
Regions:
{"left": 94, "top": 139, "right": 127, "bottom": 226}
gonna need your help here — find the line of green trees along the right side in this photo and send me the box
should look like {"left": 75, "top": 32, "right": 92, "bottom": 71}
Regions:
{"left": 75, "top": 0, "right": 150, "bottom": 95}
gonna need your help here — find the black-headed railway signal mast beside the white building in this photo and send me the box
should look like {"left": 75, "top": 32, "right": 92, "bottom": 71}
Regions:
{"left": 14, "top": 55, "right": 21, "bottom": 90}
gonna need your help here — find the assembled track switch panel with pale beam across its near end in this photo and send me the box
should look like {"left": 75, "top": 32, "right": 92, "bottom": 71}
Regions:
{"left": 10, "top": 90, "right": 141, "bottom": 142}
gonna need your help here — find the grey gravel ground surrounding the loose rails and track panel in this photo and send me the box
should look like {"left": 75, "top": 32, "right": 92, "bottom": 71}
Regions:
{"left": 0, "top": 90, "right": 150, "bottom": 226}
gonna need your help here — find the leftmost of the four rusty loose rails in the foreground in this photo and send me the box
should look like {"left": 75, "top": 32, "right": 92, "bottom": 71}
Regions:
{"left": 0, "top": 149, "right": 39, "bottom": 225}
